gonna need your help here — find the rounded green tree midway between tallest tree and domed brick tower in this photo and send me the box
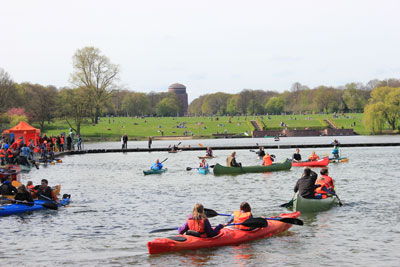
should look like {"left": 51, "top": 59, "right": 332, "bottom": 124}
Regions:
{"left": 122, "top": 93, "right": 150, "bottom": 116}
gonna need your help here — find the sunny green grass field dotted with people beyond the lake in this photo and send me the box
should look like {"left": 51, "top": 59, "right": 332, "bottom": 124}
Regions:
{"left": 34, "top": 114, "right": 368, "bottom": 141}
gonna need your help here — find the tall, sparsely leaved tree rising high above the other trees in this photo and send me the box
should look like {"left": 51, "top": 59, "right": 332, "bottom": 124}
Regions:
{"left": 71, "top": 47, "right": 119, "bottom": 123}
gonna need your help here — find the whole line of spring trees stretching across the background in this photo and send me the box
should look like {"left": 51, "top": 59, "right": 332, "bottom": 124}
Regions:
{"left": 0, "top": 47, "right": 400, "bottom": 136}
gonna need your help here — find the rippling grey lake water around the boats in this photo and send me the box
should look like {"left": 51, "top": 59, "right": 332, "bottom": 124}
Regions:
{"left": 0, "top": 137, "right": 400, "bottom": 266}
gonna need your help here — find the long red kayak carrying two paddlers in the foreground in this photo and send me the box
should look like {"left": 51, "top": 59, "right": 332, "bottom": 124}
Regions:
{"left": 147, "top": 212, "right": 300, "bottom": 254}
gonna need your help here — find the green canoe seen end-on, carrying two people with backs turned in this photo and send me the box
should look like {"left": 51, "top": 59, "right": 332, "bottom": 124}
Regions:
{"left": 293, "top": 194, "right": 338, "bottom": 213}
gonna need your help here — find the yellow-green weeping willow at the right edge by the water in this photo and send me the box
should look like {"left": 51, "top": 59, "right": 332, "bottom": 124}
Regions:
{"left": 364, "top": 86, "right": 400, "bottom": 132}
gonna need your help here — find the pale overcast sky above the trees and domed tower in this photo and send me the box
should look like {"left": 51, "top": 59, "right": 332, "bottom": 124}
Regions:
{"left": 0, "top": 0, "right": 400, "bottom": 101}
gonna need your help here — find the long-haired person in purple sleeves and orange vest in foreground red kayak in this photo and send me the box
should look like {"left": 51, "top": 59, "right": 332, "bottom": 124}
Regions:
{"left": 178, "top": 204, "right": 224, "bottom": 238}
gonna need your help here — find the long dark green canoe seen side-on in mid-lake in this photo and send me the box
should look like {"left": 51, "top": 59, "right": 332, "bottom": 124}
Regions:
{"left": 214, "top": 159, "right": 292, "bottom": 175}
